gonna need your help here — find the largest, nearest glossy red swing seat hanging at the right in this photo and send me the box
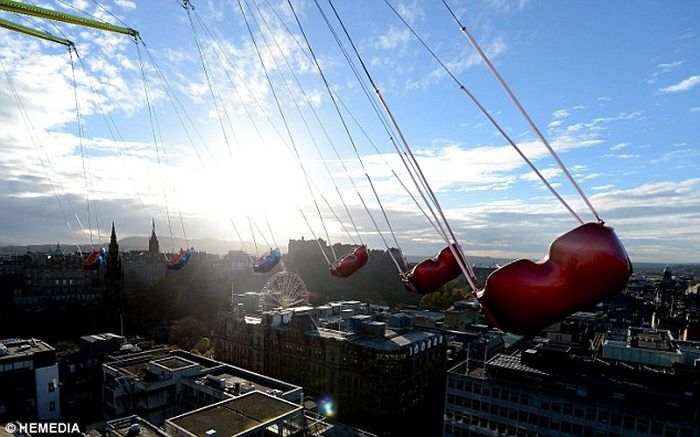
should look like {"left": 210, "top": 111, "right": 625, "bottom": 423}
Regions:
{"left": 477, "top": 223, "right": 632, "bottom": 334}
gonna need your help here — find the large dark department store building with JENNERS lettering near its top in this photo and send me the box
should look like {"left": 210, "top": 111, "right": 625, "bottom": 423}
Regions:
{"left": 214, "top": 304, "right": 446, "bottom": 435}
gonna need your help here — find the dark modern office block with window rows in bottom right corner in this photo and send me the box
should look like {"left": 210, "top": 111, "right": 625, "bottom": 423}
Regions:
{"left": 443, "top": 340, "right": 700, "bottom": 437}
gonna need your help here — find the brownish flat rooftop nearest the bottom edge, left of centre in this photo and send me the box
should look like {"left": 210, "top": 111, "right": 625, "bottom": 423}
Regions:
{"left": 168, "top": 391, "right": 302, "bottom": 437}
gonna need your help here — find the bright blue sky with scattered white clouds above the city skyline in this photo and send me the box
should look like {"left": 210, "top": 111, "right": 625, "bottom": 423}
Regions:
{"left": 0, "top": 0, "right": 700, "bottom": 263}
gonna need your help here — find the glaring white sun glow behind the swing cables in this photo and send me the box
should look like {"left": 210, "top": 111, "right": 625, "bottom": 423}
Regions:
{"left": 169, "top": 131, "right": 311, "bottom": 242}
